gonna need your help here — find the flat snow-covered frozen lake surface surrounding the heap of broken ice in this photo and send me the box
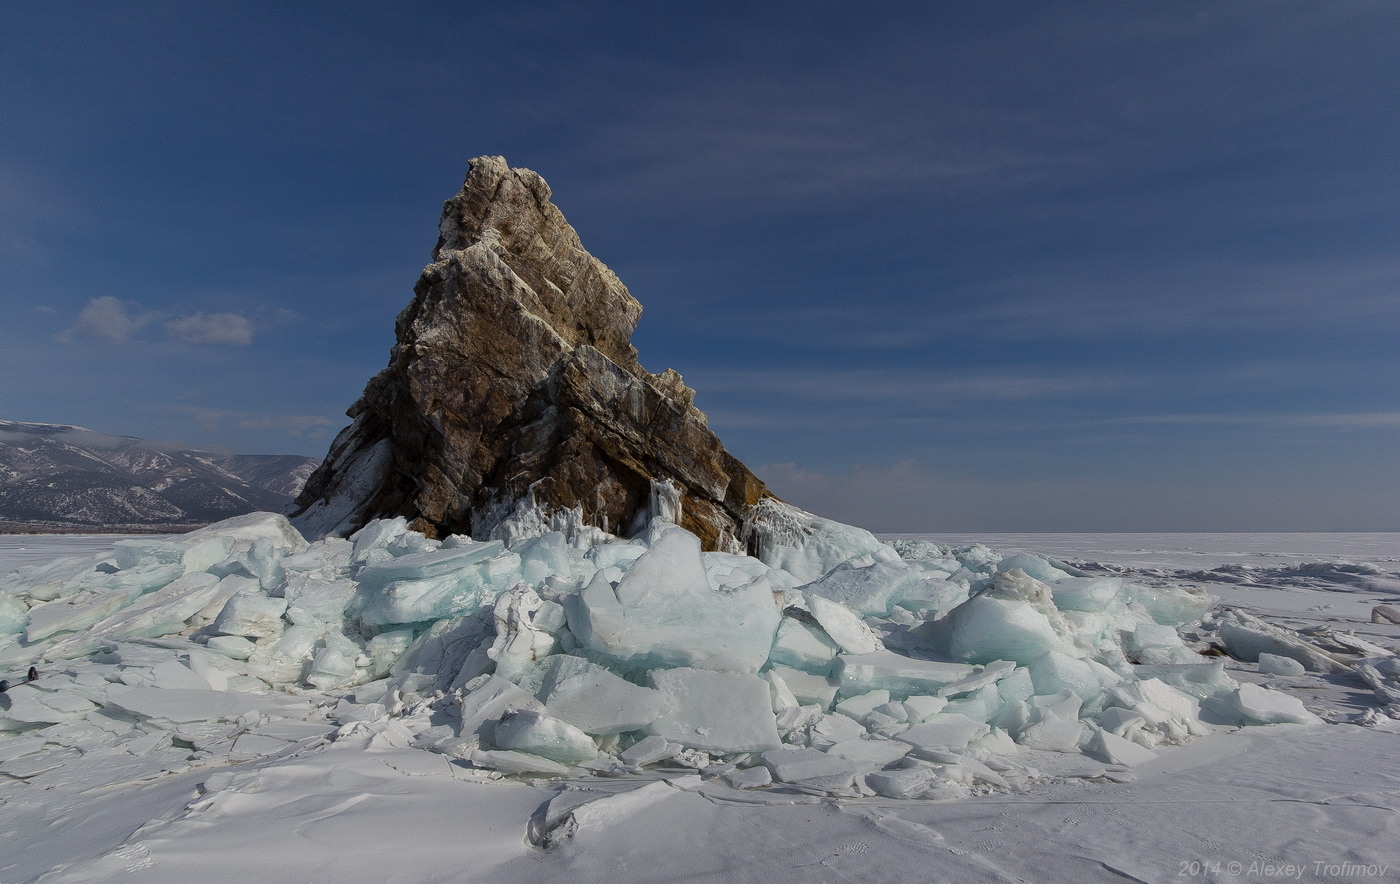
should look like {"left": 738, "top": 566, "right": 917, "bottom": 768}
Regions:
{"left": 0, "top": 534, "right": 1400, "bottom": 883}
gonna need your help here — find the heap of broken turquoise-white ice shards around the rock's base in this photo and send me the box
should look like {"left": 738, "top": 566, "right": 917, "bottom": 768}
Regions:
{"left": 0, "top": 488, "right": 1316, "bottom": 797}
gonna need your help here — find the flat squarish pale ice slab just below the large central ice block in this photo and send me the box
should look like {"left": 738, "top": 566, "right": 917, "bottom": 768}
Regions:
{"left": 647, "top": 667, "right": 780, "bottom": 752}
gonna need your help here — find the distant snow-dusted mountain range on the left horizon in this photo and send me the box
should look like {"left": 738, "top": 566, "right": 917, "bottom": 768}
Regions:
{"left": 0, "top": 420, "right": 319, "bottom": 532}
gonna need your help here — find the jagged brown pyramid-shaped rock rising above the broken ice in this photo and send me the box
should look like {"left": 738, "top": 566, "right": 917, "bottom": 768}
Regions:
{"left": 291, "top": 157, "right": 767, "bottom": 549}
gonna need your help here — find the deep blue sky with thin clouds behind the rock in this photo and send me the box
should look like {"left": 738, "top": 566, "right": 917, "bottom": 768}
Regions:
{"left": 0, "top": 0, "right": 1400, "bottom": 531}
